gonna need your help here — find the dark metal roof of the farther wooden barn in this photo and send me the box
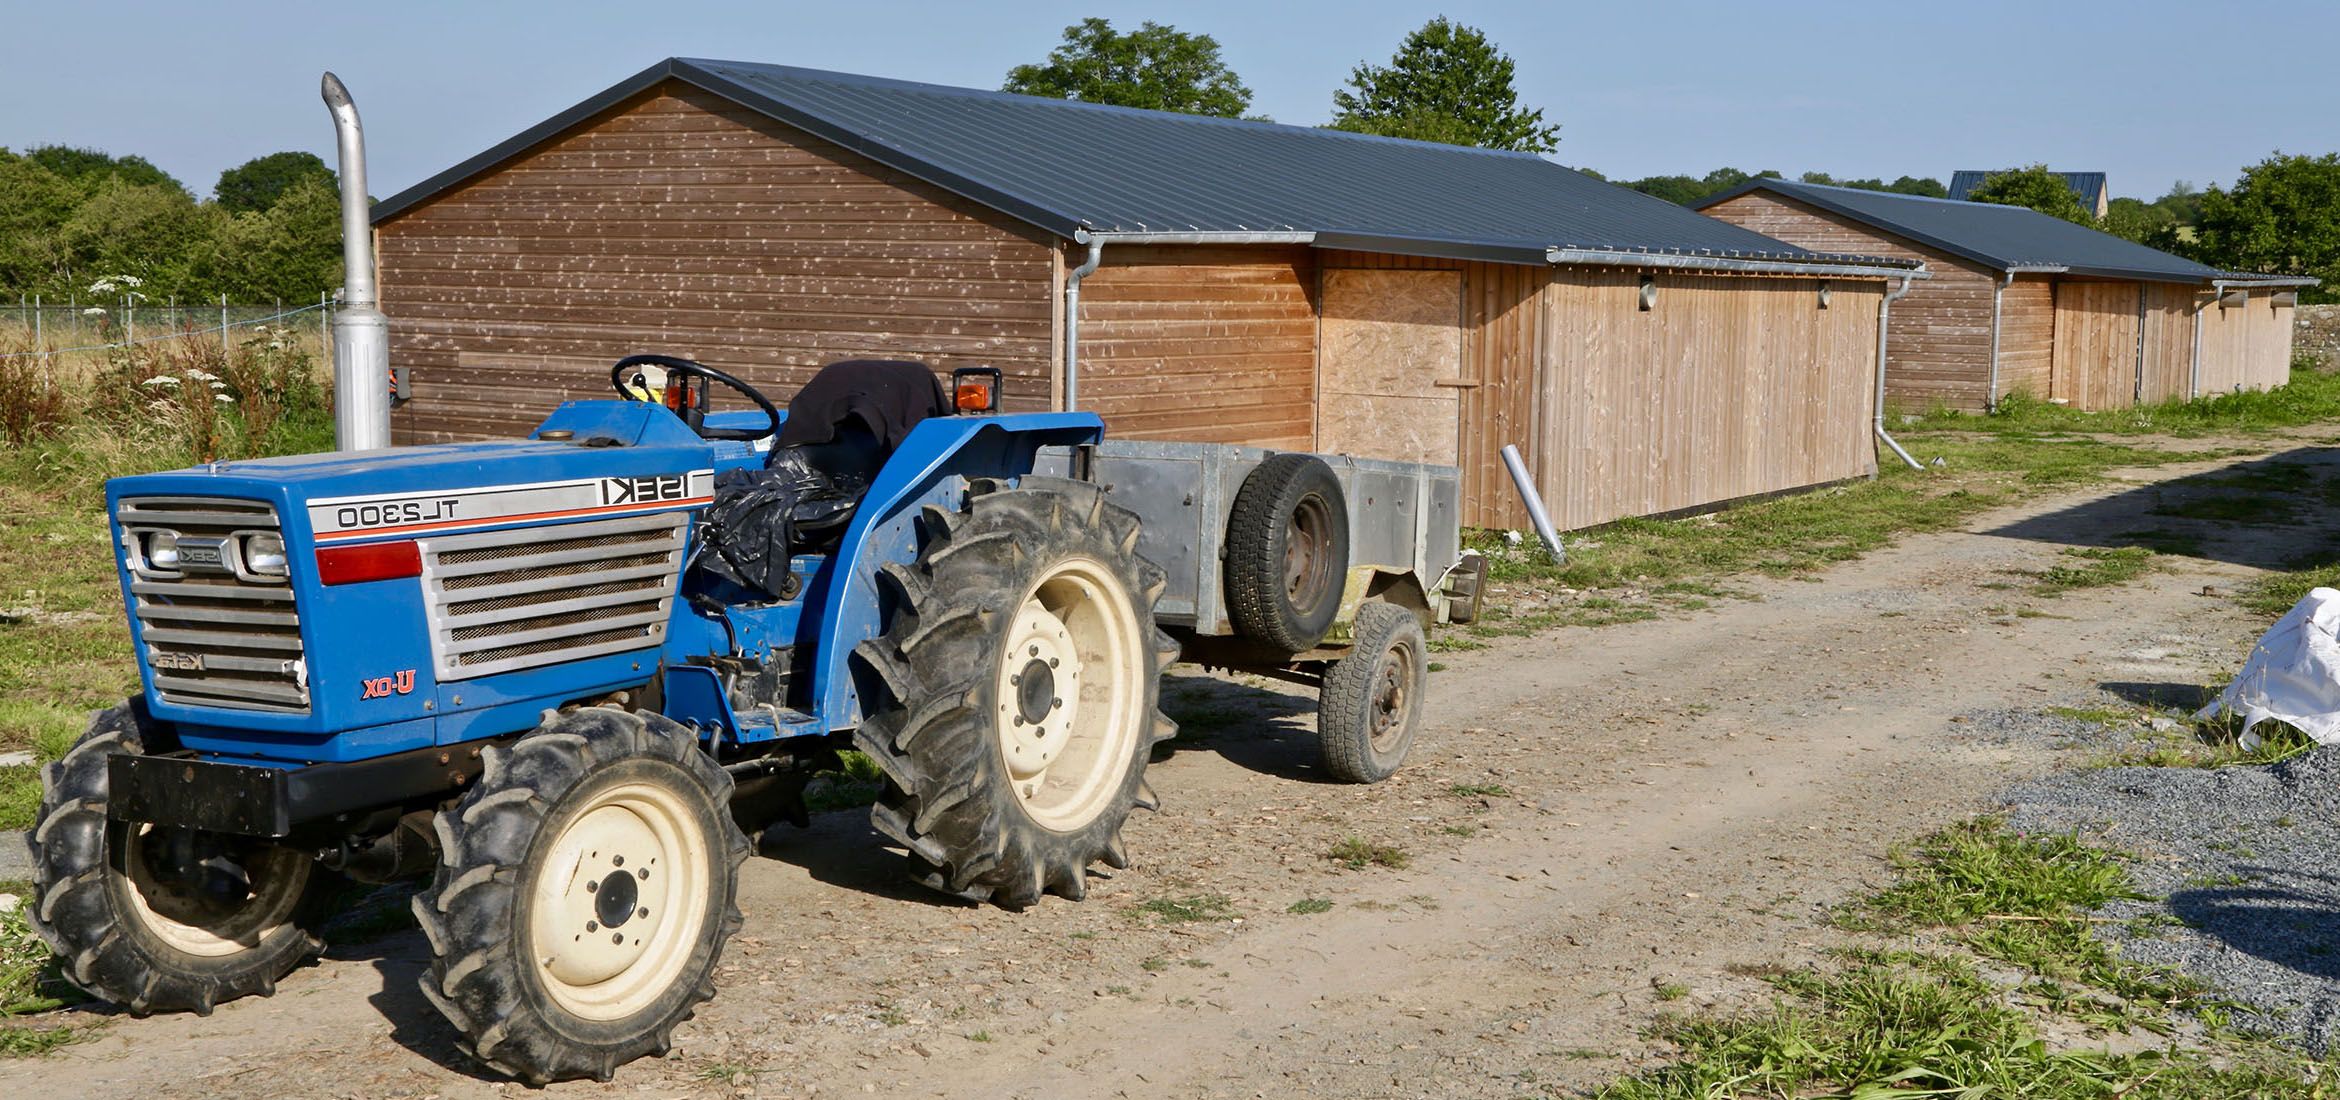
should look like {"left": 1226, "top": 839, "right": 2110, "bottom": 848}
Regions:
{"left": 1692, "top": 178, "right": 2314, "bottom": 286}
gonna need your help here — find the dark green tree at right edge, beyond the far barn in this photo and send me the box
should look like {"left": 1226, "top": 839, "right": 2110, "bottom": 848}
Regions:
{"left": 2186, "top": 152, "right": 2340, "bottom": 302}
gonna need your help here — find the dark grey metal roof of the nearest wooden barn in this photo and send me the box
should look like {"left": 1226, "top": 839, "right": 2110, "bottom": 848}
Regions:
{"left": 374, "top": 59, "right": 1912, "bottom": 274}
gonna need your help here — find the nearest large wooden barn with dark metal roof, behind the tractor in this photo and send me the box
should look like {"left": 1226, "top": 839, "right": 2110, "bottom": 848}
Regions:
{"left": 374, "top": 59, "right": 1923, "bottom": 527}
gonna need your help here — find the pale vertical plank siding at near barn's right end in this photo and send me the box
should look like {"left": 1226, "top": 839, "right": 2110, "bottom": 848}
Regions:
{"left": 1540, "top": 269, "right": 1884, "bottom": 529}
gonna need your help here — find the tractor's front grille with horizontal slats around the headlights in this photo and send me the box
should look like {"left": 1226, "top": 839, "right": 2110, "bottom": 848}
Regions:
{"left": 115, "top": 496, "right": 309, "bottom": 714}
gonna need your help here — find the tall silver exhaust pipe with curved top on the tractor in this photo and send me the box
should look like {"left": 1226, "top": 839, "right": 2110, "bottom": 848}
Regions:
{"left": 323, "top": 73, "right": 391, "bottom": 452}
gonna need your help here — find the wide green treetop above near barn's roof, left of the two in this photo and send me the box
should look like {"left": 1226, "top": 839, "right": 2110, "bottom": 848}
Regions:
{"left": 1002, "top": 19, "right": 1252, "bottom": 119}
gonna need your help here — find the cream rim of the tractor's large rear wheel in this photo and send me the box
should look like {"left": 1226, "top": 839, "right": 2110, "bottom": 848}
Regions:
{"left": 992, "top": 557, "right": 1147, "bottom": 831}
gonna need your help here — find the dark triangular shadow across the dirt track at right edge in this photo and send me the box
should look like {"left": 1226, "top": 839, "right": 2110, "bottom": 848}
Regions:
{"left": 1989, "top": 447, "right": 2340, "bottom": 569}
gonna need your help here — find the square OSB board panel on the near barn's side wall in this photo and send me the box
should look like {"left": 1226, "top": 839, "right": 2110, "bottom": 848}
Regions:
{"left": 1317, "top": 269, "right": 1465, "bottom": 466}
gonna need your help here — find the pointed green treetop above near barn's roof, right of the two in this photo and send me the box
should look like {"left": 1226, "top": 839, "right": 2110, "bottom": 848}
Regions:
{"left": 1331, "top": 16, "right": 1561, "bottom": 152}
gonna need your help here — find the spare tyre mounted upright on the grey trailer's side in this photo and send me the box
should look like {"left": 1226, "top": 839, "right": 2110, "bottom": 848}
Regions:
{"left": 1221, "top": 454, "right": 1348, "bottom": 653}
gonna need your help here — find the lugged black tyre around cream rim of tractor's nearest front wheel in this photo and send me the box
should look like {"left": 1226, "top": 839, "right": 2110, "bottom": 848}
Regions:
{"left": 414, "top": 707, "right": 749, "bottom": 1086}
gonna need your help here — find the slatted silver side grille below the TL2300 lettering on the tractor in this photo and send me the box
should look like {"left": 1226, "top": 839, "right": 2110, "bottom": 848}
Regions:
{"left": 419, "top": 513, "right": 686, "bottom": 681}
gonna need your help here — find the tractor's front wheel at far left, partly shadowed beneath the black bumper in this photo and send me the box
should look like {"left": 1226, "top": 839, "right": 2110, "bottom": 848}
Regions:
{"left": 30, "top": 700, "right": 335, "bottom": 1016}
